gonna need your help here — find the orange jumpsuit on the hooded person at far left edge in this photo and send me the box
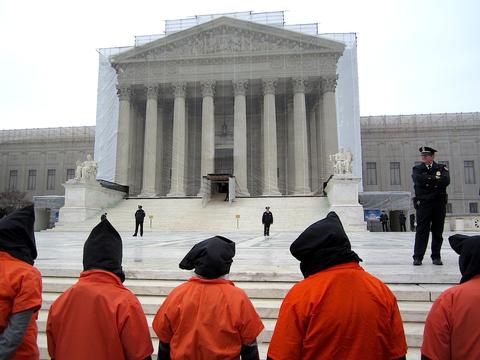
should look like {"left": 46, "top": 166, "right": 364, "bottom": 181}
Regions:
{"left": 0, "top": 252, "right": 42, "bottom": 360}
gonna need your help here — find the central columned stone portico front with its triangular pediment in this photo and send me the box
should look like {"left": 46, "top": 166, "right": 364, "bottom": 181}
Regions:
{"left": 106, "top": 17, "right": 345, "bottom": 197}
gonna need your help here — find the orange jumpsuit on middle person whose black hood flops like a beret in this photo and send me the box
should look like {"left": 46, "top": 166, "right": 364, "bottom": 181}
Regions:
{"left": 153, "top": 277, "right": 263, "bottom": 360}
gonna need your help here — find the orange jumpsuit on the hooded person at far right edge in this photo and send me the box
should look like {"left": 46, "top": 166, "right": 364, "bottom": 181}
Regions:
{"left": 422, "top": 275, "right": 480, "bottom": 360}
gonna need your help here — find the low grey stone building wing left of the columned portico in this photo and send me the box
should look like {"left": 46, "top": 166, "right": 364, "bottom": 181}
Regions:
{"left": 0, "top": 126, "right": 95, "bottom": 199}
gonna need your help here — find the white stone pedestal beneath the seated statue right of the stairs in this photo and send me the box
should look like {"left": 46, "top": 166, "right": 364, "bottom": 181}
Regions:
{"left": 325, "top": 174, "right": 367, "bottom": 231}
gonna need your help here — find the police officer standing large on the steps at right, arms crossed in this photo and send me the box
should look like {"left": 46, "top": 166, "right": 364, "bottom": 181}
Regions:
{"left": 412, "top": 146, "right": 450, "bottom": 265}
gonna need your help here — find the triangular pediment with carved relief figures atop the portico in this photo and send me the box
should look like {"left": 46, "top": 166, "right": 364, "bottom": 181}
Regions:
{"left": 113, "top": 17, "right": 344, "bottom": 63}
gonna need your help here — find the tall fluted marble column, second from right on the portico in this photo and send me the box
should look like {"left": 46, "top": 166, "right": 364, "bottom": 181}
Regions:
{"left": 292, "top": 79, "right": 310, "bottom": 195}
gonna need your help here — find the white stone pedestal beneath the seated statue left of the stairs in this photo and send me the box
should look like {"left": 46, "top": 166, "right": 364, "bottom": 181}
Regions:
{"left": 58, "top": 180, "right": 125, "bottom": 226}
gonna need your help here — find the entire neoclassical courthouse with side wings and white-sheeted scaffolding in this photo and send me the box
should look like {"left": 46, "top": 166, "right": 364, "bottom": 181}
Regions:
{"left": 0, "top": 12, "right": 480, "bottom": 219}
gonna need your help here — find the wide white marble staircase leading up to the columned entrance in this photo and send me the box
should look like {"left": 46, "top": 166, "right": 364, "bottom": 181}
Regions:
{"left": 50, "top": 194, "right": 329, "bottom": 233}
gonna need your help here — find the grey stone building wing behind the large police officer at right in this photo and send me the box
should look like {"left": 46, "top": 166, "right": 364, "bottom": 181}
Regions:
{"left": 361, "top": 112, "right": 480, "bottom": 214}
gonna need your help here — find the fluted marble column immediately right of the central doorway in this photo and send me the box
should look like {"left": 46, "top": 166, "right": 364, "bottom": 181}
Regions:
{"left": 233, "top": 80, "right": 250, "bottom": 196}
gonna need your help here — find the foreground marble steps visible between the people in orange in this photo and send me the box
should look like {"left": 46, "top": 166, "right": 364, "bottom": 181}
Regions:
{"left": 38, "top": 268, "right": 450, "bottom": 359}
